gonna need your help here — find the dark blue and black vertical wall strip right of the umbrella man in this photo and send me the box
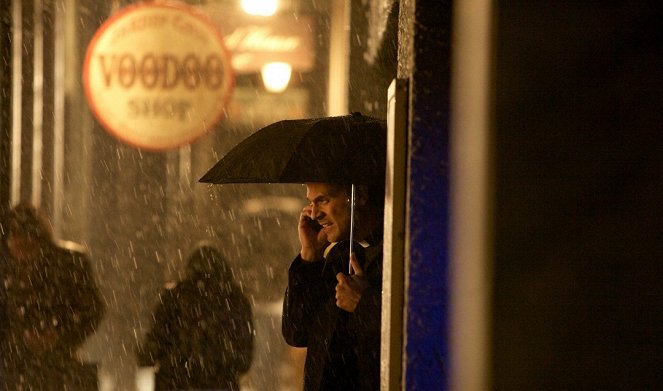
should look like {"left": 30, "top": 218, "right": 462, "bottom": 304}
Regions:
{"left": 398, "top": 1, "right": 452, "bottom": 390}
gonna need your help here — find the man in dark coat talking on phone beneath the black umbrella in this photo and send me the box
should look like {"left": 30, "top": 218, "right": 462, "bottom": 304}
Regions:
{"left": 282, "top": 183, "right": 384, "bottom": 390}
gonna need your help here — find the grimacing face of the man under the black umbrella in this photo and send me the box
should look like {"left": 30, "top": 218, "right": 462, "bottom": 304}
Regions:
{"left": 306, "top": 183, "right": 350, "bottom": 242}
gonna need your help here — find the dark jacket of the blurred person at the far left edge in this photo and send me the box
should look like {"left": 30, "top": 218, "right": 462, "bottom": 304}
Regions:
{"left": 0, "top": 245, "right": 105, "bottom": 390}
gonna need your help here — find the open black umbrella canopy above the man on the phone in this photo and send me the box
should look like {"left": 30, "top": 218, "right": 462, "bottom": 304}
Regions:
{"left": 199, "top": 113, "right": 387, "bottom": 184}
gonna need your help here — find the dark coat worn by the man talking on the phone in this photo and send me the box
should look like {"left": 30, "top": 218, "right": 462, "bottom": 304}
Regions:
{"left": 282, "top": 242, "right": 382, "bottom": 391}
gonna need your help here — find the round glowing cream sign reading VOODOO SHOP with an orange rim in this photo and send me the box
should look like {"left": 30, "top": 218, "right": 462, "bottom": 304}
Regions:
{"left": 83, "top": 3, "right": 233, "bottom": 150}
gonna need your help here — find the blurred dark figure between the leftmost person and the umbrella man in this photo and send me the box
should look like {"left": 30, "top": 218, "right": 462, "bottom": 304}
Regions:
{"left": 137, "top": 242, "right": 254, "bottom": 391}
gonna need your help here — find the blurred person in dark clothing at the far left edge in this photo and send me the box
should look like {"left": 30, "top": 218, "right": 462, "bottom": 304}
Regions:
{"left": 0, "top": 203, "right": 105, "bottom": 390}
